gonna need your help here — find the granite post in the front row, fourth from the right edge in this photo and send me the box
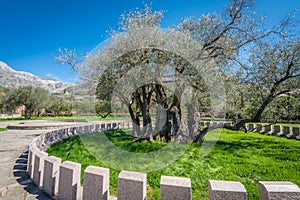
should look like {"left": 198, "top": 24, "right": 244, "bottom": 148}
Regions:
{"left": 118, "top": 171, "right": 147, "bottom": 200}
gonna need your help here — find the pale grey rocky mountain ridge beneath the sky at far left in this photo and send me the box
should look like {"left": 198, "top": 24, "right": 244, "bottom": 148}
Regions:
{"left": 0, "top": 61, "right": 67, "bottom": 93}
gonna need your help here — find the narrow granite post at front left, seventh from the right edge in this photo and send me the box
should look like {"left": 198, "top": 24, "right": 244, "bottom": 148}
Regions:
{"left": 43, "top": 156, "right": 61, "bottom": 196}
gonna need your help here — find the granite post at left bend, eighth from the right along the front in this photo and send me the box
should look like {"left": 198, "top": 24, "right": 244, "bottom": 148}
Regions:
{"left": 32, "top": 150, "right": 48, "bottom": 187}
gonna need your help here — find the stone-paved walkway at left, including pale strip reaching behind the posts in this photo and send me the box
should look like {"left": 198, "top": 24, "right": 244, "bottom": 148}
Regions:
{"left": 0, "top": 121, "right": 90, "bottom": 200}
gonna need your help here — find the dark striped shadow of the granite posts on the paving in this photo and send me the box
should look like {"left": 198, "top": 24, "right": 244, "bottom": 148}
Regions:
{"left": 13, "top": 151, "right": 52, "bottom": 200}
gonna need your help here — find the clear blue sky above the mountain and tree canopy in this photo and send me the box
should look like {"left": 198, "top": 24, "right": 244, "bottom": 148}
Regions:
{"left": 0, "top": 0, "right": 300, "bottom": 82}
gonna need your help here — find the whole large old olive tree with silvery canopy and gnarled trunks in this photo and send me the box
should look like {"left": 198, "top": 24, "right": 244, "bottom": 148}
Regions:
{"left": 57, "top": 0, "right": 300, "bottom": 142}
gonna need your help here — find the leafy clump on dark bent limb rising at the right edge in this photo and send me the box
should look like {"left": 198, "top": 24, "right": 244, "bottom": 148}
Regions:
{"left": 226, "top": 37, "right": 300, "bottom": 128}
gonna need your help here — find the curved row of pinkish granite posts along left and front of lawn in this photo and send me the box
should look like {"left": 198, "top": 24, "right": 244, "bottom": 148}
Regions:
{"left": 27, "top": 121, "right": 300, "bottom": 200}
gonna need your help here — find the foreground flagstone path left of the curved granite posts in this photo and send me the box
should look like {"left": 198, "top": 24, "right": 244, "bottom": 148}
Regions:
{"left": 0, "top": 127, "right": 50, "bottom": 200}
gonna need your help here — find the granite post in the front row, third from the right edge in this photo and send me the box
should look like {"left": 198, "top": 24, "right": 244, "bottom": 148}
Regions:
{"left": 160, "top": 176, "right": 192, "bottom": 200}
